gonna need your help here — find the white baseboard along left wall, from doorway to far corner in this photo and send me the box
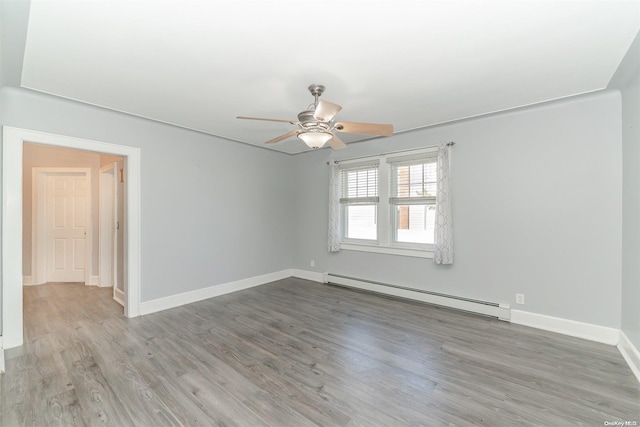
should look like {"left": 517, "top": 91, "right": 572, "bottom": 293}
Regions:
{"left": 140, "top": 270, "right": 292, "bottom": 316}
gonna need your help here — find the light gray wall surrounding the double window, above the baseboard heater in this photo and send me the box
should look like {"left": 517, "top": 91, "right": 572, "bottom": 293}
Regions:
{"left": 294, "top": 91, "right": 622, "bottom": 328}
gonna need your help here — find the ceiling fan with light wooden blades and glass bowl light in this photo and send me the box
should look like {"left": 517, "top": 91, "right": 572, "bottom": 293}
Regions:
{"left": 237, "top": 84, "right": 393, "bottom": 150}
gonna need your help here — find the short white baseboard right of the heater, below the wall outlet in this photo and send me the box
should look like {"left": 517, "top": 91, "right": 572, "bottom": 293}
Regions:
{"left": 511, "top": 309, "right": 620, "bottom": 345}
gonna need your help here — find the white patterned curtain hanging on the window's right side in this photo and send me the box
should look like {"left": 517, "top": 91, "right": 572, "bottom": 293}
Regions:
{"left": 433, "top": 144, "right": 453, "bottom": 264}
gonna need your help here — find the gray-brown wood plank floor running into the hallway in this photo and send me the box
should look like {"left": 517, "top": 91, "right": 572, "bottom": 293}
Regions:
{"left": 0, "top": 278, "right": 640, "bottom": 427}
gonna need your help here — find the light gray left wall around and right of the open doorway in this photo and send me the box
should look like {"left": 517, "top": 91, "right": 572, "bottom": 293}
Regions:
{"left": 0, "top": 87, "right": 294, "bottom": 301}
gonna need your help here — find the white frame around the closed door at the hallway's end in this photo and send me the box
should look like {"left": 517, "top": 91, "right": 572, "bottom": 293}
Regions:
{"left": 31, "top": 167, "right": 93, "bottom": 286}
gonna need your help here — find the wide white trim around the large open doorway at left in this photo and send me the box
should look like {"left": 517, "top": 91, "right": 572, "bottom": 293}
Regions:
{"left": 2, "top": 126, "right": 141, "bottom": 348}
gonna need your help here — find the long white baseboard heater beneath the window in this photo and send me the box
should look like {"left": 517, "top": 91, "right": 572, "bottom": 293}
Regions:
{"left": 324, "top": 273, "right": 511, "bottom": 322}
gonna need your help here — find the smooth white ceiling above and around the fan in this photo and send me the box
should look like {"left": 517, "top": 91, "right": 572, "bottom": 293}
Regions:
{"left": 22, "top": 0, "right": 640, "bottom": 154}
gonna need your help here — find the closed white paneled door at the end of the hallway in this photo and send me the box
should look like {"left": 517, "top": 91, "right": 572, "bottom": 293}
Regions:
{"left": 45, "top": 173, "right": 90, "bottom": 282}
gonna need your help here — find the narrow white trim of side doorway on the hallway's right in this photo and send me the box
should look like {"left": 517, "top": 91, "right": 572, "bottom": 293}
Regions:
{"left": 98, "top": 162, "right": 118, "bottom": 289}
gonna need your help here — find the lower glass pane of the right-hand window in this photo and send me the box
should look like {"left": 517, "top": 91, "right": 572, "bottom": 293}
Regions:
{"left": 396, "top": 205, "right": 436, "bottom": 244}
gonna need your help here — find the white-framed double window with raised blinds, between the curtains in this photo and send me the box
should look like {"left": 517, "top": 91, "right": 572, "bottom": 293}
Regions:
{"left": 340, "top": 149, "right": 438, "bottom": 257}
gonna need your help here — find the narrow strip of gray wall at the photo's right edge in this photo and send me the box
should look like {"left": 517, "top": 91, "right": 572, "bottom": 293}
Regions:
{"left": 610, "top": 30, "right": 640, "bottom": 348}
